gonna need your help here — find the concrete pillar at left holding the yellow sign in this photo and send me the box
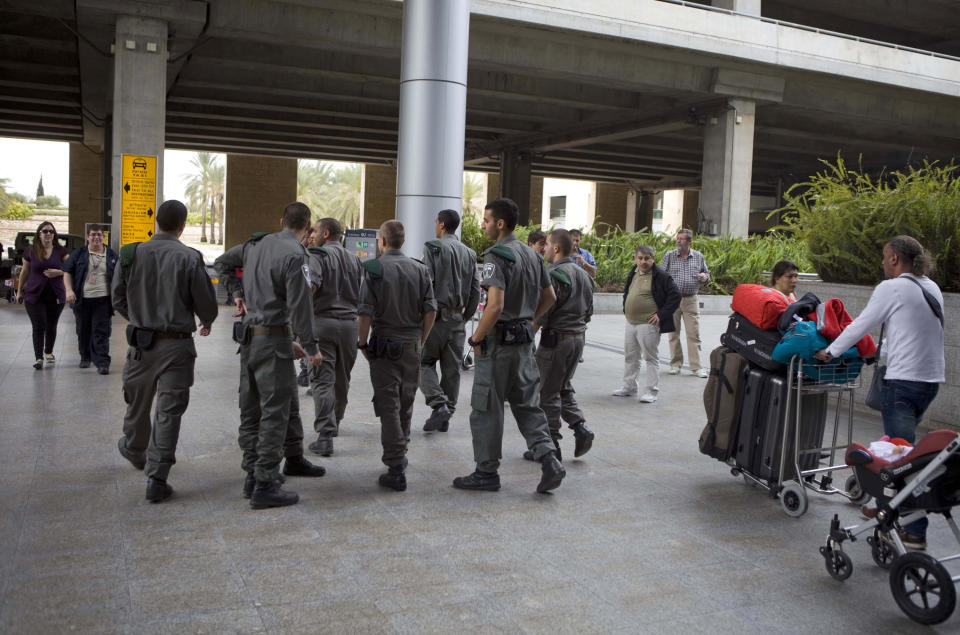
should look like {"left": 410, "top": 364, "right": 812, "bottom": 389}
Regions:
{"left": 110, "top": 15, "right": 168, "bottom": 249}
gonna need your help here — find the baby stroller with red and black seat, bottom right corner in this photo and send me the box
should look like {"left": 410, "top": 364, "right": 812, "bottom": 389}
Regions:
{"left": 820, "top": 430, "right": 960, "bottom": 624}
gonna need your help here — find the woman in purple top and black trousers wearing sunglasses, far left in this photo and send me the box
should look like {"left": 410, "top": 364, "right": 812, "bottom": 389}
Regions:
{"left": 20, "top": 221, "right": 68, "bottom": 370}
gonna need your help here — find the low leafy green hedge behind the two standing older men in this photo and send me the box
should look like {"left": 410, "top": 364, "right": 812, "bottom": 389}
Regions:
{"left": 581, "top": 227, "right": 811, "bottom": 295}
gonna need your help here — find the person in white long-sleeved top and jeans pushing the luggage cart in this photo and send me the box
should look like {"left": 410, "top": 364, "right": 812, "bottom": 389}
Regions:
{"left": 817, "top": 236, "right": 945, "bottom": 549}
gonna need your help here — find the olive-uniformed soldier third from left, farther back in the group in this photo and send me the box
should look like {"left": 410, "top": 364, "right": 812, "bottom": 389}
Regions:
{"left": 308, "top": 218, "right": 363, "bottom": 456}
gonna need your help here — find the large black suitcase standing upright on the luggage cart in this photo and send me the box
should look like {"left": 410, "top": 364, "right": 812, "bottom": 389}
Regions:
{"left": 753, "top": 373, "right": 828, "bottom": 481}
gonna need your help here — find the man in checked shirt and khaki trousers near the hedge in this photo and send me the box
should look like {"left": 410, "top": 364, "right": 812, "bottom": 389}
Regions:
{"left": 660, "top": 229, "right": 710, "bottom": 379}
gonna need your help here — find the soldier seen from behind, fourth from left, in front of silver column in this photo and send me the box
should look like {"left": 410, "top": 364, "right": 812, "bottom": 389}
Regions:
{"left": 358, "top": 220, "right": 437, "bottom": 492}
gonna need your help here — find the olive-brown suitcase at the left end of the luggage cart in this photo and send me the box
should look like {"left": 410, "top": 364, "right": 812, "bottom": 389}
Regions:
{"left": 700, "top": 346, "right": 748, "bottom": 461}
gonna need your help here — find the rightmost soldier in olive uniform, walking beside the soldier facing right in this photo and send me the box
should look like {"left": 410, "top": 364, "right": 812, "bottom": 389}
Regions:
{"left": 523, "top": 229, "right": 594, "bottom": 461}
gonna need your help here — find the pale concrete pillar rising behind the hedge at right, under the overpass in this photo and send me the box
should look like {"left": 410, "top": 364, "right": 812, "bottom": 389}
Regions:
{"left": 700, "top": 99, "right": 755, "bottom": 236}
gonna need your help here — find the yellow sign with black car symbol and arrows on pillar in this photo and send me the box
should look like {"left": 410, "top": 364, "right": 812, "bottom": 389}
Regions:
{"left": 120, "top": 154, "right": 157, "bottom": 247}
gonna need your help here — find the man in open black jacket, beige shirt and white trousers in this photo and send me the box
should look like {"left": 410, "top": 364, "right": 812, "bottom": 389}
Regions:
{"left": 613, "top": 245, "right": 680, "bottom": 403}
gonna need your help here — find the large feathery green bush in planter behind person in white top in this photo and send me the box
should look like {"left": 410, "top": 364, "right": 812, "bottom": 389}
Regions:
{"left": 777, "top": 156, "right": 960, "bottom": 291}
